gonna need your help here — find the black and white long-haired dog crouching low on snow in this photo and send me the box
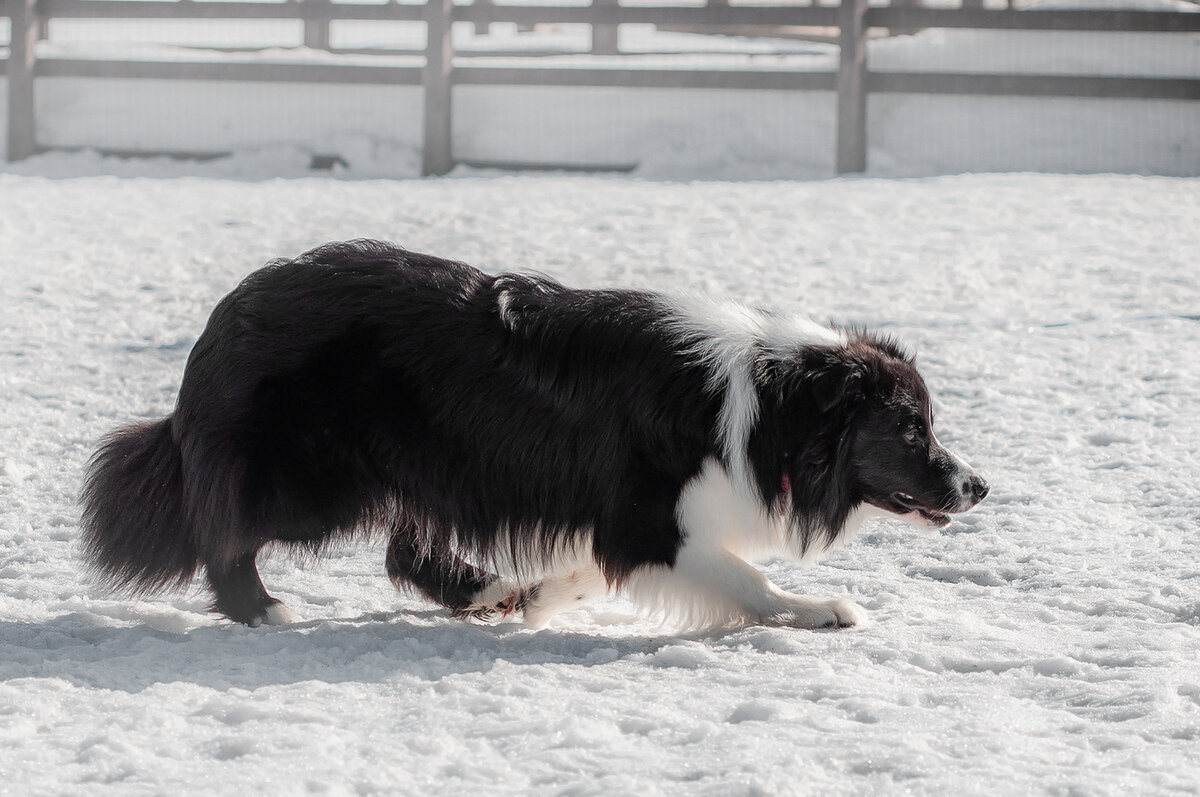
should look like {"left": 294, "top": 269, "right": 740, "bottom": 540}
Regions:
{"left": 82, "top": 241, "right": 988, "bottom": 628}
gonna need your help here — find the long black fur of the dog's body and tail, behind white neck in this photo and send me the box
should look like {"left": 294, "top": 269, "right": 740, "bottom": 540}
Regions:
{"left": 83, "top": 236, "right": 718, "bottom": 588}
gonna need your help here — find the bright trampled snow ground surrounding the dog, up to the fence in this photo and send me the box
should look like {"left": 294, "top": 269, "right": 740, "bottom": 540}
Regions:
{"left": 0, "top": 166, "right": 1200, "bottom": 795}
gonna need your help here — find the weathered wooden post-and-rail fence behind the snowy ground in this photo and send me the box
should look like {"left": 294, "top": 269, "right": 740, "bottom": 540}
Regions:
{"left": 7, "top": 0, "right": 1200, "bottom": 174}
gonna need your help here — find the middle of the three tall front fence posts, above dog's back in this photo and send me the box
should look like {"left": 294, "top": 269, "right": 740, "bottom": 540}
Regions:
{"left": 421, "top": 0, "right": 454, "bottom": 175}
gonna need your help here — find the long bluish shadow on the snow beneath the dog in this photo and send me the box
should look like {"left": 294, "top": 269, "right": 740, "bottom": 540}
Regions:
{"left": 0, "top": 611, "right": 710, "bottom": 693}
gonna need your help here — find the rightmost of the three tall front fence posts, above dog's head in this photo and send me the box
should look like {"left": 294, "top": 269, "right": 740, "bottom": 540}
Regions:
{"left": 838, "top": 0, "right": 868, "bottom": 174}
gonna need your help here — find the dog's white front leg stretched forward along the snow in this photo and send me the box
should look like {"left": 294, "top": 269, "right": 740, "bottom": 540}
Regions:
{"left": 628, "top": 543, "right": 866, "bottom": 628}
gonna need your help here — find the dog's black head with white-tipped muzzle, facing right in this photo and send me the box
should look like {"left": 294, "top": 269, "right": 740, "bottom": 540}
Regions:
{"left": 801, "top": 332, "right": 988, "bottom": 528}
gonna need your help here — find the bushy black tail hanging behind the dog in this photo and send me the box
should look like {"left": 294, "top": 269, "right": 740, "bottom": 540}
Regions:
{"left": 80, "top": 418, "right": 198, "bottom": 594}
